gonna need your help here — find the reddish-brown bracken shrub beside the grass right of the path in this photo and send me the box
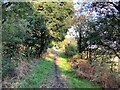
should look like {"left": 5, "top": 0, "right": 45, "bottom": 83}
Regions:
{"left": 70, "top": 59, "right": 118, "bottom": 89}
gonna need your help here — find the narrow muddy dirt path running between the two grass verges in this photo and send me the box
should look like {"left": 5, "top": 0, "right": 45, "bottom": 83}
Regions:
{"left": 40, "top": 51, "right": 67, "bottom": 88}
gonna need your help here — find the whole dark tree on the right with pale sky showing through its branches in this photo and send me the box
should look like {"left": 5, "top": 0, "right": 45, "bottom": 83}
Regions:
{"left": 75, "top": 2, "right": 120, "bottom": 64}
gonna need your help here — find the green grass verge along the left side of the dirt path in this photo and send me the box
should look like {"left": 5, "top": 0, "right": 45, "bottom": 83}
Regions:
{"left": 18, "top": 57, "right": 53, "bottom": 88}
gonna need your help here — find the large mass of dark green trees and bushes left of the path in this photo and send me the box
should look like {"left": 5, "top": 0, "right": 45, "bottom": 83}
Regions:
{"left": 2, "top": 2, "right": 49, "bottom": 76}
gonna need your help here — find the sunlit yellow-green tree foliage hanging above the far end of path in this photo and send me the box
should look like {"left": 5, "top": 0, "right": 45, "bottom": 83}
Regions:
{"left": 34, "top": 2, "right": 74, "bottom": 41}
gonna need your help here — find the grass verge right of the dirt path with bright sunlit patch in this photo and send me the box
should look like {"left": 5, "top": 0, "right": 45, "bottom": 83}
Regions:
{"left": 58, "top": 53, "right": 101, "bottom": 90}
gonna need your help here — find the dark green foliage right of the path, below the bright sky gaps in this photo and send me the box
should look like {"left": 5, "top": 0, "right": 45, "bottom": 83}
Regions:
{"left": 76, "top": 3, "right": 120, "bottom": 62}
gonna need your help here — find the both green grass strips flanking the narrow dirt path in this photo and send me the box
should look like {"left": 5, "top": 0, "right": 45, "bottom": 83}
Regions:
{"left": 19, "top": 52, "right": 100, "bottom": 90}
